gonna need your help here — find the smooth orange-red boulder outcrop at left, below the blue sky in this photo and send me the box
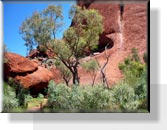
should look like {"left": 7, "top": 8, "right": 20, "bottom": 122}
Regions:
{"left": 4, "top": 53, "right": 54, "bottom": 92}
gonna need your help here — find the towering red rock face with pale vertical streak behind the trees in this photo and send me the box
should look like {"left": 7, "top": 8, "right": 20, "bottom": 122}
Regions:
{"left": 77, "top": 0, "right": 147, "bottom": 84}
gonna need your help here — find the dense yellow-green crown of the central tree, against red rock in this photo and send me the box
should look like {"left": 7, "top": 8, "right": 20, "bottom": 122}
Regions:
{"left": 64, "top": 6, "right": 103, "bottom": 58}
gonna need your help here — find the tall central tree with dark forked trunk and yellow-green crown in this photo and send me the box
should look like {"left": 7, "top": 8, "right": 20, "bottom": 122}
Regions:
{"left": 51, "top": 6, "right": 103, "bottom": 84}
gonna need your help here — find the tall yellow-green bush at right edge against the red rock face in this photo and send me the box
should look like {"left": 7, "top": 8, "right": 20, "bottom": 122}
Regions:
{"left": 119, "top": 49, "right": 147, "bottom": 109}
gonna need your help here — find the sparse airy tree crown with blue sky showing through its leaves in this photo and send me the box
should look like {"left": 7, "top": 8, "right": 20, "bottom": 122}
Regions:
{"left": 20, "top": 5, "right": 63, "bottom": 51}
